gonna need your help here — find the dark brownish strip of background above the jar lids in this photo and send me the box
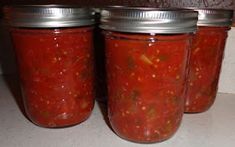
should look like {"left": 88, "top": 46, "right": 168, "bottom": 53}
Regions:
{"left": 0, "top": 0, "right": 235, "bottom": 23}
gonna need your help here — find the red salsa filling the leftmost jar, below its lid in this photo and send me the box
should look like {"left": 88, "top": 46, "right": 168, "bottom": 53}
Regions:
{"left": 11, "top": 27, "right": 94, "bottom": 127}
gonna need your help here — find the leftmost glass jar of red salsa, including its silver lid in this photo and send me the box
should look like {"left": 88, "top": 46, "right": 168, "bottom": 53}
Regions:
{"left": 5, "top": 5, "right": 94, "bottom": 128}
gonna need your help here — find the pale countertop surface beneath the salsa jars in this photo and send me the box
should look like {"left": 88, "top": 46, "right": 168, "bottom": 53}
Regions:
{"left": 0, "top": 76, "right": 235, "bottom": 147}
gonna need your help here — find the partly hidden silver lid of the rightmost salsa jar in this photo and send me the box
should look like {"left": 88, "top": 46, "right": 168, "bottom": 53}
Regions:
{"left": 194, "top": 9, "right": 233, "bottom": 27}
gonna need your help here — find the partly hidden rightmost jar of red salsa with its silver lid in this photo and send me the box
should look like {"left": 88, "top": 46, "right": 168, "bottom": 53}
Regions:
{"left": 185, "top": 9, "right": 233, "bottom": 113}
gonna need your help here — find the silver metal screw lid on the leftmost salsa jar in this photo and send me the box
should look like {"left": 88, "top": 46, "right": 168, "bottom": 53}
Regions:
{"left": 4, "top": 5, "right": 95, "bottom": 28}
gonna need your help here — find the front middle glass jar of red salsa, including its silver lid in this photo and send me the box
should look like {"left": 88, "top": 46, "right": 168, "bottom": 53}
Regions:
{"left": 100, "top": 7, "right": 197, "bottom": 143}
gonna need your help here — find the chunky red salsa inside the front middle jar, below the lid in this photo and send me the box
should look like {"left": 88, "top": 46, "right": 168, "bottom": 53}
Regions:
{"left": 105, "top": 32, "right": 191, "bottom": 143}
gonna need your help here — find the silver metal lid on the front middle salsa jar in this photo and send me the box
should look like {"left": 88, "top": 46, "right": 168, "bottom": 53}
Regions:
{"left": 100, "top": 6, "right": 198, "bottom": 34}
